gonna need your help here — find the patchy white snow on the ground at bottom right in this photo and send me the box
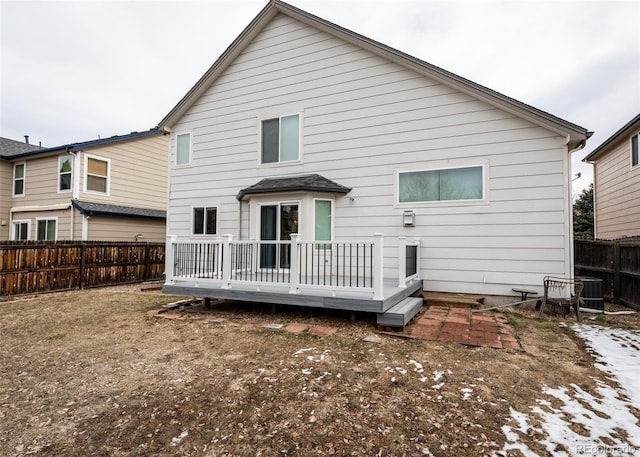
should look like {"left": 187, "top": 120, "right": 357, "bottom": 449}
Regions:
{"left": 494, "top": 325, "right": 640, "bottom": 457}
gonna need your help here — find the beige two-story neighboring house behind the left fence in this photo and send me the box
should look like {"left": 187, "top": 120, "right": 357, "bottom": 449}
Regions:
{"left": 0, "top": 129, "right": 168, "bottom": 242}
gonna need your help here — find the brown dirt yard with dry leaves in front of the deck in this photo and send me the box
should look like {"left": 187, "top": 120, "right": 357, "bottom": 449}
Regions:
{"left": 0, "top": 287, "right": 640, "bottom": 456}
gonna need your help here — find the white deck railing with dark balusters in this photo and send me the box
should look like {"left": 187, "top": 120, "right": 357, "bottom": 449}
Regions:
{"left": 166, "top": 233, "right": 420, "bottom": 299}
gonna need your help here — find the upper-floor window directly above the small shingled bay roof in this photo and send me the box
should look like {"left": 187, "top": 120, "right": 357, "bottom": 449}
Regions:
{"left": 260, "top": 114, "right": 300, "bottom": 163}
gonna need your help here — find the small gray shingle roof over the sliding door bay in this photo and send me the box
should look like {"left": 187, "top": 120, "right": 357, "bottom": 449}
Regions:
{"left": 236, "top": 174, "right": 351, "bottom": 200}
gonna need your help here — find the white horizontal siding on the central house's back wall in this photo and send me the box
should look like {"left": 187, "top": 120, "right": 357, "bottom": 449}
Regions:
{"left": 168, "top": 15, "right": 572, "bottom": 295}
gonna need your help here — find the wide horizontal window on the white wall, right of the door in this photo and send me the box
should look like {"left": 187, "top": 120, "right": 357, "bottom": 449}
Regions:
{"left": 398, "top": 166, "right": 484, "bottom": 203}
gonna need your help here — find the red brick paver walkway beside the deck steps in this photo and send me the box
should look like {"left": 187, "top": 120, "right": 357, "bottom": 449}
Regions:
{"left": 411, "top": 306, "right": 522, "bottom": 350}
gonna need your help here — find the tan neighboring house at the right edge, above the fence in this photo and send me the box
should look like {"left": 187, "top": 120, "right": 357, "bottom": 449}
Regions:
{"left": 583, "top": 114, "right": 640, "bottom": 239}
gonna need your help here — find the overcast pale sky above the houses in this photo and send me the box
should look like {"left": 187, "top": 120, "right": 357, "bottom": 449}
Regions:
{"left": 0, "top": 0, "right": 640, "bottom": 192}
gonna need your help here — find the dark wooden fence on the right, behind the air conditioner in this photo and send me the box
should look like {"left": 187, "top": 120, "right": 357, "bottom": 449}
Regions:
{"left": 575, "top": 238, "right": 640, "bottom": 310}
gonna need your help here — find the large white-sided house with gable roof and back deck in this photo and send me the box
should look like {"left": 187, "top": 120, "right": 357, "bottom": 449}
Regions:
{"left": 159, "top": 0, "right": 589, "bottom": 322}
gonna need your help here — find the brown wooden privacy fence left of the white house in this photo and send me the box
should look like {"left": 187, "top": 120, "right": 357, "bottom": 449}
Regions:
{"left": 0, "top": 241, "right": 165, "bottom": 296}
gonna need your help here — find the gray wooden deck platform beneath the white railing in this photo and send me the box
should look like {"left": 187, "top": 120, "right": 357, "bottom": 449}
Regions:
{"left": 162, "top": 279, "right": 422, "bottom": 313}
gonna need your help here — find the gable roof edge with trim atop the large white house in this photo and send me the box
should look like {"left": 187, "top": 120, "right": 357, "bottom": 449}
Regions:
{"left": 158, "top": 0, "right": 591, "bottom": 150}
